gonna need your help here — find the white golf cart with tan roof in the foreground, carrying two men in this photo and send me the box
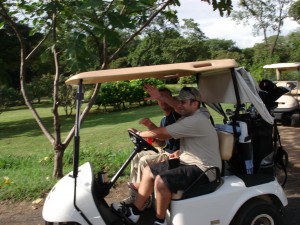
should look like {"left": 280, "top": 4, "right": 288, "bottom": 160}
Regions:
{"left": 43, "top": 59, "right": 288, "bottom": 225}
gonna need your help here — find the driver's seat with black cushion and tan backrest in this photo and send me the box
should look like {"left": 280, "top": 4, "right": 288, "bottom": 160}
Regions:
{"left": 172, "top": 131, "right": 234, "bottom": 200}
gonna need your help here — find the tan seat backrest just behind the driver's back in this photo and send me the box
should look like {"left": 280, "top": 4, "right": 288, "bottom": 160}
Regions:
{"left": 217, "top": 131, "right": 234, "bottom": 161}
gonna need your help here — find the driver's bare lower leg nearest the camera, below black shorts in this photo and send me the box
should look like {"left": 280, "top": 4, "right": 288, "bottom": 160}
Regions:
{"left": 154, "top": 175, "right": 172, "bottom": 219}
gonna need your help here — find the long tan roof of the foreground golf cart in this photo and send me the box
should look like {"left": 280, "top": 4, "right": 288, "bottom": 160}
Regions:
{"left": 66, "top": 59, "right": 237, "bottom": 85}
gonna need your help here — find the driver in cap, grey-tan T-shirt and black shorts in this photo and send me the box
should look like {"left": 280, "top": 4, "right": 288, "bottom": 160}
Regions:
{"left": 112, "top": 85, "right": 221, "bottom": 225}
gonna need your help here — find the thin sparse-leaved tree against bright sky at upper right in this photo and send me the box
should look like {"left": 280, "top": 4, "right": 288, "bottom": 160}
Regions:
{"left": 231, "top": 0, "right": 292, "bottom": 58}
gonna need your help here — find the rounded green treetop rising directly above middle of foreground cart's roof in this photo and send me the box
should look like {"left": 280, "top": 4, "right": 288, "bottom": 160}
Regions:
{"left": 128, "top": 19, "right": 207, "bottom": 66}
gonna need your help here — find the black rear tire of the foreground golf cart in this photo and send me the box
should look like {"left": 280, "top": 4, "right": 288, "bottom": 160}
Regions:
{"left": 230, "top": 199, "right": 283, "bottom": 225}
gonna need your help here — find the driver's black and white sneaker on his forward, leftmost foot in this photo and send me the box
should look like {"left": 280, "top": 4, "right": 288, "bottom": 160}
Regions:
{"left": 111, "top": 203, "right": 140, "bottom": 224}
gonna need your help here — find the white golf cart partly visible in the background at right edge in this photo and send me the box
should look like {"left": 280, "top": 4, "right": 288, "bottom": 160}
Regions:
{"left": 263, "top": 63, "right": 300, "bottom": 127}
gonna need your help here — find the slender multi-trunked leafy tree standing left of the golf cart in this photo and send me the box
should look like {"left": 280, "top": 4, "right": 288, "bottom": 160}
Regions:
{"left": 0, "top": 0, "right": 231, "bottom": 177}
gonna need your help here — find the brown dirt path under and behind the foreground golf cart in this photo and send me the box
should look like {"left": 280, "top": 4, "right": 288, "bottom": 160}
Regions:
{"left": 0, "top": 127, "right": 300, "bottom": 225}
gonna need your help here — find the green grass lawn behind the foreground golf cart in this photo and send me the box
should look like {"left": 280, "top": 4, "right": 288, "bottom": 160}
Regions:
{"left": 0, "top": 99, "right": 225, "bottom": 201}
